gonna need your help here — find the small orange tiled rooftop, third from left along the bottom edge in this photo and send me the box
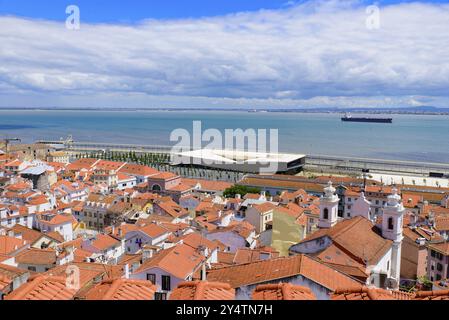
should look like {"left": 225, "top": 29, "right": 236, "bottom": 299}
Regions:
{"left": 170, "top": 281, "right": 235, "bottom": 301}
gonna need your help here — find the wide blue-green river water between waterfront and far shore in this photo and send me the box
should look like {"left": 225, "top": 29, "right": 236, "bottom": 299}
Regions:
{"left": 0, "top": 110, "right": 449, "bottom": 163}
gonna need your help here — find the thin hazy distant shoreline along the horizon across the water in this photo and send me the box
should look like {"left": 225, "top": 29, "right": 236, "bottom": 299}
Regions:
{"left": 0, "top": 107, "right": 449, "bottom": 116}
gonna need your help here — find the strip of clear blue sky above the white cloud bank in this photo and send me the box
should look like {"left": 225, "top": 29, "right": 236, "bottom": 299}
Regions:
{"left": 0, "top": 0, "right": 448, "bottom": 23}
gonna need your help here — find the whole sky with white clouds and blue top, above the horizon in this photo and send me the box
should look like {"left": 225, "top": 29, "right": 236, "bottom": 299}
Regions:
{"left": 0, "top": 0, "right": 449, "bottom": 108}
